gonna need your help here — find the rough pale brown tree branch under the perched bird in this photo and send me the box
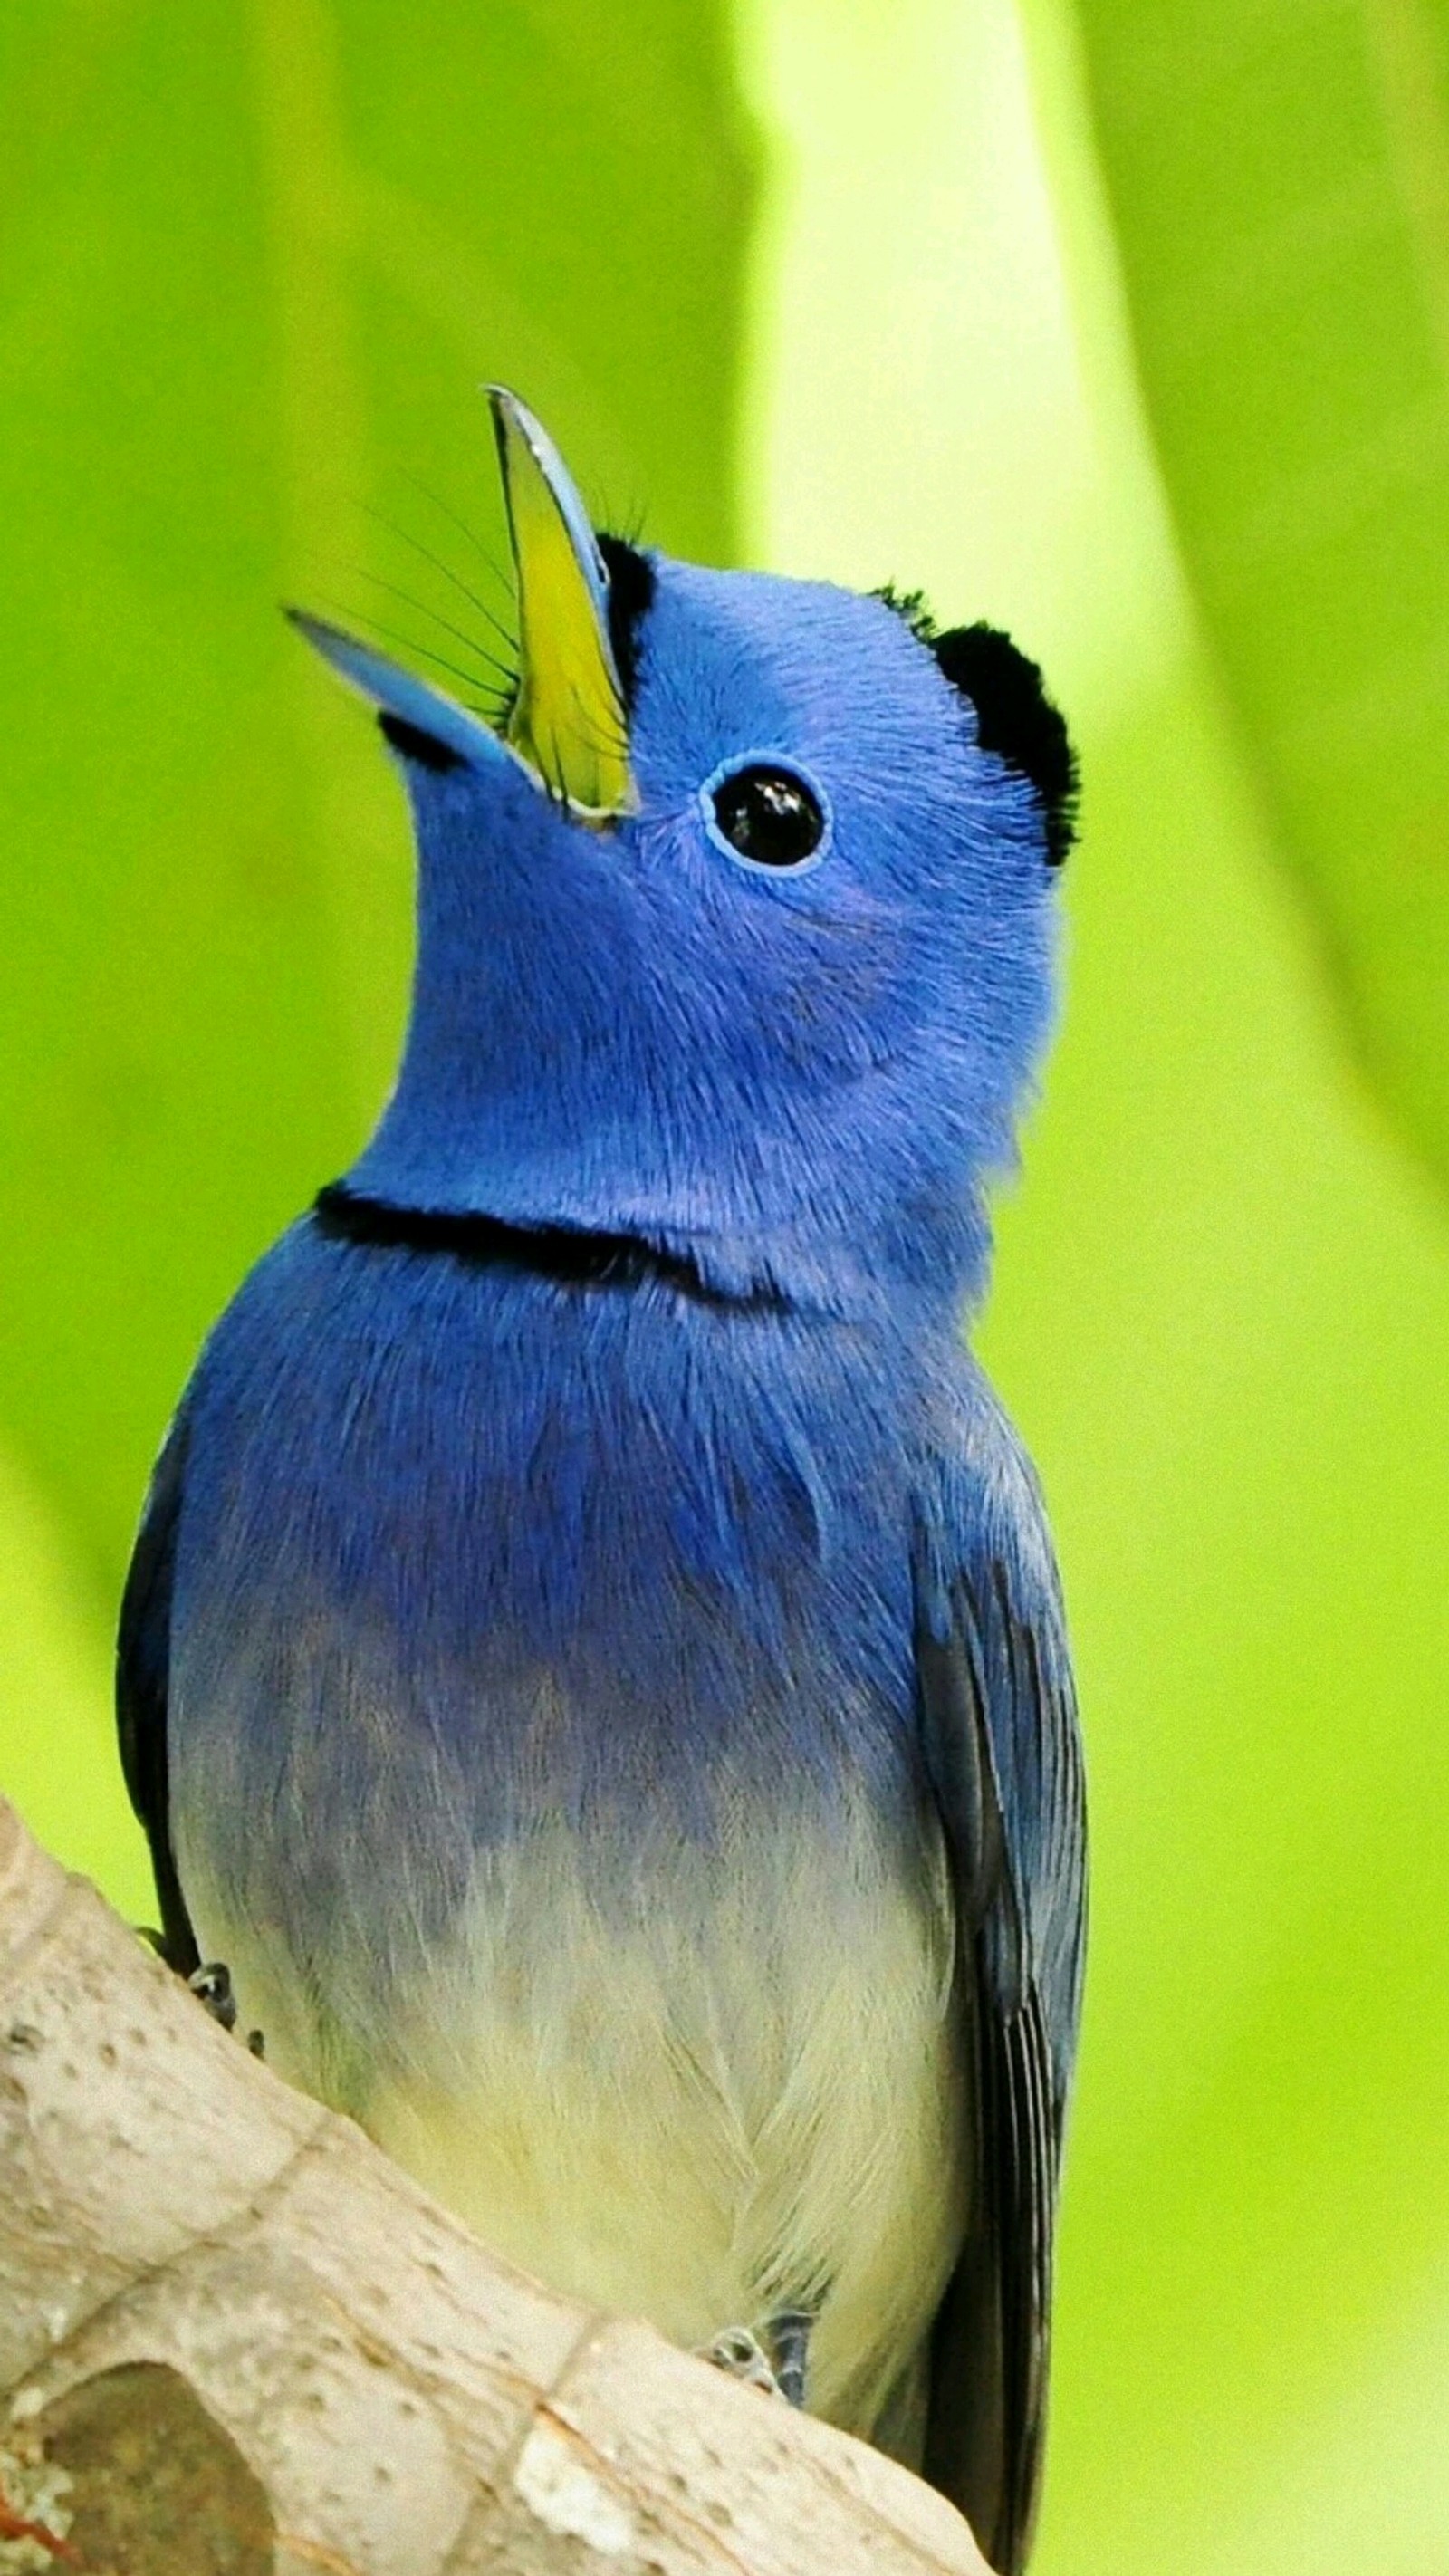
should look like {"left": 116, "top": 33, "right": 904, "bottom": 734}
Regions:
{"left": 0, "top": 1803, "right": 985, "bottom": 2576}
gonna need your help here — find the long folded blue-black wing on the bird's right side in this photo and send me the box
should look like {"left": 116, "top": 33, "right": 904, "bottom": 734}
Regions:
{"left": 916, "top": 1412, "right": 1086, "bottom": 2576}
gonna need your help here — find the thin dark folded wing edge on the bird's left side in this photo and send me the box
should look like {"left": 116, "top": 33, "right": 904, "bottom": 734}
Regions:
{"left": 116, "top": 1414, "right": 201, "bottom": 1975}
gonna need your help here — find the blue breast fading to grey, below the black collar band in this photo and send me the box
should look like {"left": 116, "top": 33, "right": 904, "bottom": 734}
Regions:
{"left": 170, "top": 1221, "right": 1024, "bottom": 2020}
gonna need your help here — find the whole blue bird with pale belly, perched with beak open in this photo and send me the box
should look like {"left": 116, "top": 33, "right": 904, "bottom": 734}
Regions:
{"left": 119, "top": 391, "right": 1083, "bottom": 2576}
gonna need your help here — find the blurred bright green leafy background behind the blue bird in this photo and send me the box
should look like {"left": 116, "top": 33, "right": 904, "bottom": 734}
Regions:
{"left": 0, "top": 0, "right": 1449, "bottom": 2576}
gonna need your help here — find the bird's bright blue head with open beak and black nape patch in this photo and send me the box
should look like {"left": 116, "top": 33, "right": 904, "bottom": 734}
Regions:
{"left": 299, "top": 391, "right": 1073, "bottom": 1306}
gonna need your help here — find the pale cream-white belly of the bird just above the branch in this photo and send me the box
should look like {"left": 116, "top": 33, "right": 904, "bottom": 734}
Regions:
{"left": 206, "top": 1816, "right": 968, "bottom": 2432}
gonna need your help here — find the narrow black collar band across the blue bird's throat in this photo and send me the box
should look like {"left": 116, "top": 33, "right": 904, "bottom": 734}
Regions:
{"left": 312, "top": 1180, "right": 790, "bottom": 1313}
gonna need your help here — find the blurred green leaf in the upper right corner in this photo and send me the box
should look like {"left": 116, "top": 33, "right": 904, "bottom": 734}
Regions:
{"left": 1081, "top": 0, "right": 1449, "bottom": 1177}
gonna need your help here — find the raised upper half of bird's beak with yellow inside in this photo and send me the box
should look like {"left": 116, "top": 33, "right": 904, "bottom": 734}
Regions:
{"left": 489, "top": 384, "right": 636, "bottom": 827}
